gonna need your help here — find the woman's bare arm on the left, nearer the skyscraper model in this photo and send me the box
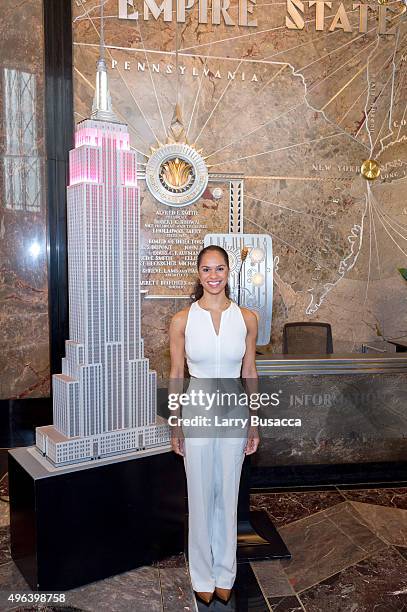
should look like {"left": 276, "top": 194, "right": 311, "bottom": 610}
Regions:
{"left": 168, "top": 309, "right": 189, "bottom": 456}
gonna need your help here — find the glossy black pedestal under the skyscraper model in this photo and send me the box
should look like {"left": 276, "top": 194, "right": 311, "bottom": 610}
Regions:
{"left": 9, "top": 448, "right": 185, "bottom": 592}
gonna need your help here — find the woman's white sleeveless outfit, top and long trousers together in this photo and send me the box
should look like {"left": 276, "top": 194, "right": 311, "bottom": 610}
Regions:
{"left": 184, "top": 302, "right": 247, "bottom": 592}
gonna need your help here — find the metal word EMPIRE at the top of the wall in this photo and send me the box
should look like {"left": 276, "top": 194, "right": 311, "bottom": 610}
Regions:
{"left": 118, "top": 0, "right": 257, "bottom": 27}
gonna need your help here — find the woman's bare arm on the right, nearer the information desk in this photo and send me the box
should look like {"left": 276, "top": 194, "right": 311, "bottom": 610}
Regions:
{"left": 241, "top": 308, "right": 260, "bottom": 455}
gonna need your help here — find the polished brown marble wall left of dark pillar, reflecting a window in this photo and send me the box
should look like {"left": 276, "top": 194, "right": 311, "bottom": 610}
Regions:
{"left": 0, "top": 0, "right": 50, "bottom": 399}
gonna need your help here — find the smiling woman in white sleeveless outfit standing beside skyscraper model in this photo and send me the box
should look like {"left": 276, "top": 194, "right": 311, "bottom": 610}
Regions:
{"left": 170, "top": 245, "right": 259, "bottom": 603}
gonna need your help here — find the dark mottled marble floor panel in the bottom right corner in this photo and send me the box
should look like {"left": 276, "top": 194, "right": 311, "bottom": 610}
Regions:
{"left": 299, "top": 547, "right": 407, "bottom": 612}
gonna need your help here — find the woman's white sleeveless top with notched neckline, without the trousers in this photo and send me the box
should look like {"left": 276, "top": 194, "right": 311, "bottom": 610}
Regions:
{"left": 185, "top": 302, "right": 247, "bottom": 378}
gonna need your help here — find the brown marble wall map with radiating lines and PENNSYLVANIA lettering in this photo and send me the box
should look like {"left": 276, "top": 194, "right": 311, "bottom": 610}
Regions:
{"left": 73, "top": 0, "right": 407, "bottom": 374}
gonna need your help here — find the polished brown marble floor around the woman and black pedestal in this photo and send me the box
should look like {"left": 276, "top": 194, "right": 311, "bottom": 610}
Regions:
{"left": 0, "top": 456, "right": 407, "bottom": 612}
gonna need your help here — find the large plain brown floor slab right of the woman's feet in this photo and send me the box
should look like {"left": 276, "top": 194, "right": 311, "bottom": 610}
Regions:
{"left": 279, "top": 502, "right": 386, "bottom": 593}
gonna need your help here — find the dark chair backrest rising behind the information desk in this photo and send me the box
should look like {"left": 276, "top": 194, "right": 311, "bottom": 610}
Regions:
{"left": 283, "top": 322, "right": 333, "bottom": 355}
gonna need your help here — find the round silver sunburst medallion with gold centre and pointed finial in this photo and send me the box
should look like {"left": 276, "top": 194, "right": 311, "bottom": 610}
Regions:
{"left": 146, "top": 104, "right": 209, "bottom": 207}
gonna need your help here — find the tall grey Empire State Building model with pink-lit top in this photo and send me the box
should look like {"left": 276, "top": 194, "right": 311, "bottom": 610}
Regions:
{"left": 36, "top": 31, "right": 169, "bottom": 466}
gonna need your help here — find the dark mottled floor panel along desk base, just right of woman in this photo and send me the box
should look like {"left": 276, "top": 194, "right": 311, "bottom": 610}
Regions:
{"left": 250, "top": 491, "right": 344, "bottom": 527}
